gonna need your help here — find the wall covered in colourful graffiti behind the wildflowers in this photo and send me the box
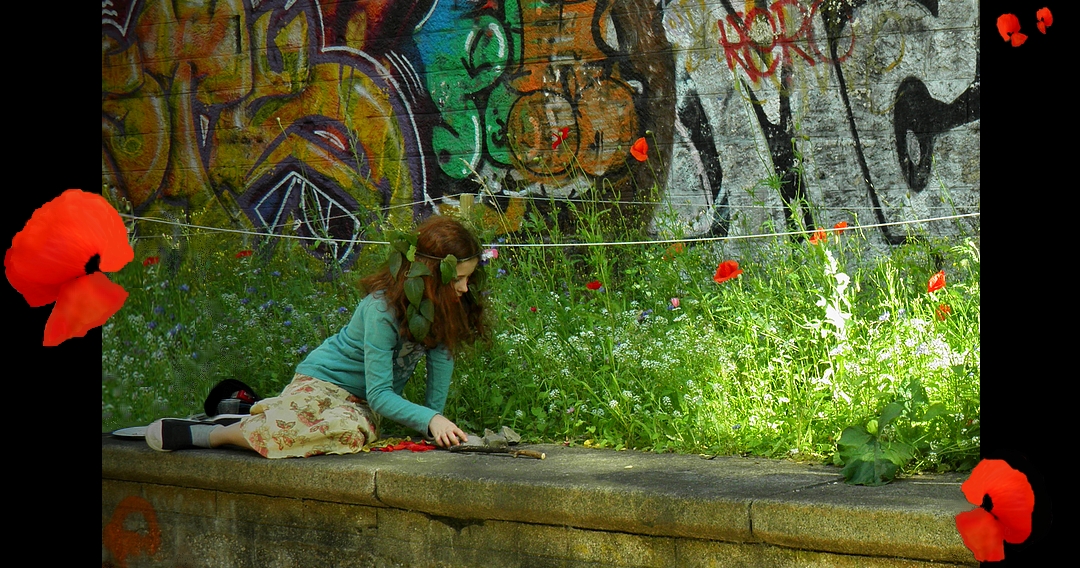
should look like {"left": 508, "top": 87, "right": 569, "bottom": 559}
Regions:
{"left": 102, "top": 0, "right": 981, "bottom": 260}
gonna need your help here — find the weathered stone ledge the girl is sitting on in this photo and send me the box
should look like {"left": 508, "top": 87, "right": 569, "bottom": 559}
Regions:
{"left": 102, "top": 434, "right": 976, "bottom": 566}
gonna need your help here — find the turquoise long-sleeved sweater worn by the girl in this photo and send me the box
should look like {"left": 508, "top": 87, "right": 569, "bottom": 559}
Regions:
{"left": 296, "top": 293, "right": 454, "bottom": 435}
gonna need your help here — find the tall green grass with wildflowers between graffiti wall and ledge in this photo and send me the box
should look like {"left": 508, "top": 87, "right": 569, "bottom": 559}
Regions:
{"left": 102, "top": 204, "right": 980, "bottom": 479}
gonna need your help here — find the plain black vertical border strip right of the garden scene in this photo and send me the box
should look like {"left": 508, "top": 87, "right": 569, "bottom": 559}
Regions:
{"left": 981, "top": 0, "right": 1062, "bottom": 567}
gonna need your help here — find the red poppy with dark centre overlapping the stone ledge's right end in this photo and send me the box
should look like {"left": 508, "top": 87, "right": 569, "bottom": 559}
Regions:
{"left": 956, "top": 459, "right": 1035, "bottom": 562}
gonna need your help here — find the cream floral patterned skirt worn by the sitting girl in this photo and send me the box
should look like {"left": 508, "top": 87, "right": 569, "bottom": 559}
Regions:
{"left": 240, "top": 373, "right": 379, "bottom": 458}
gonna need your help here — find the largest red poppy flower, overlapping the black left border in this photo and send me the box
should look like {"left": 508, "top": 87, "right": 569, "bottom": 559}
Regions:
{"left": 3, "top": 189, "right": 135, "bottom": 347}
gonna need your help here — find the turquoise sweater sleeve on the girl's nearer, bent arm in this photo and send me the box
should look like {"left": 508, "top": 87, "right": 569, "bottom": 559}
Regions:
{"left": 364, "top": 310, "right": 436, "bottom": 435}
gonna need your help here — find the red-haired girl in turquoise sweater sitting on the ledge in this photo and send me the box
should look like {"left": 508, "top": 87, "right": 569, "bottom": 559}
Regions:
{"left": 146, "top": 216, "right": 486, "bottom": 458}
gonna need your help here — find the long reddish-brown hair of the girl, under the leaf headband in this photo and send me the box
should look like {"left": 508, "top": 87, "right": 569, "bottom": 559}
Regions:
{"left": 360, "top": 215, "right": 487, "bottom": 353}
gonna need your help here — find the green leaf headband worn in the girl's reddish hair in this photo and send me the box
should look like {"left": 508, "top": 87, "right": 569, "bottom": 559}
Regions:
{"left": 387, "top": 231, "right": 480, "bottom": 341}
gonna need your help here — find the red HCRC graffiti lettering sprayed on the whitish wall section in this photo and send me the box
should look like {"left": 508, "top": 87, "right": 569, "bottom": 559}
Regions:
{"left": 717, "top": 0, "right": 855, "bottom": 82}
